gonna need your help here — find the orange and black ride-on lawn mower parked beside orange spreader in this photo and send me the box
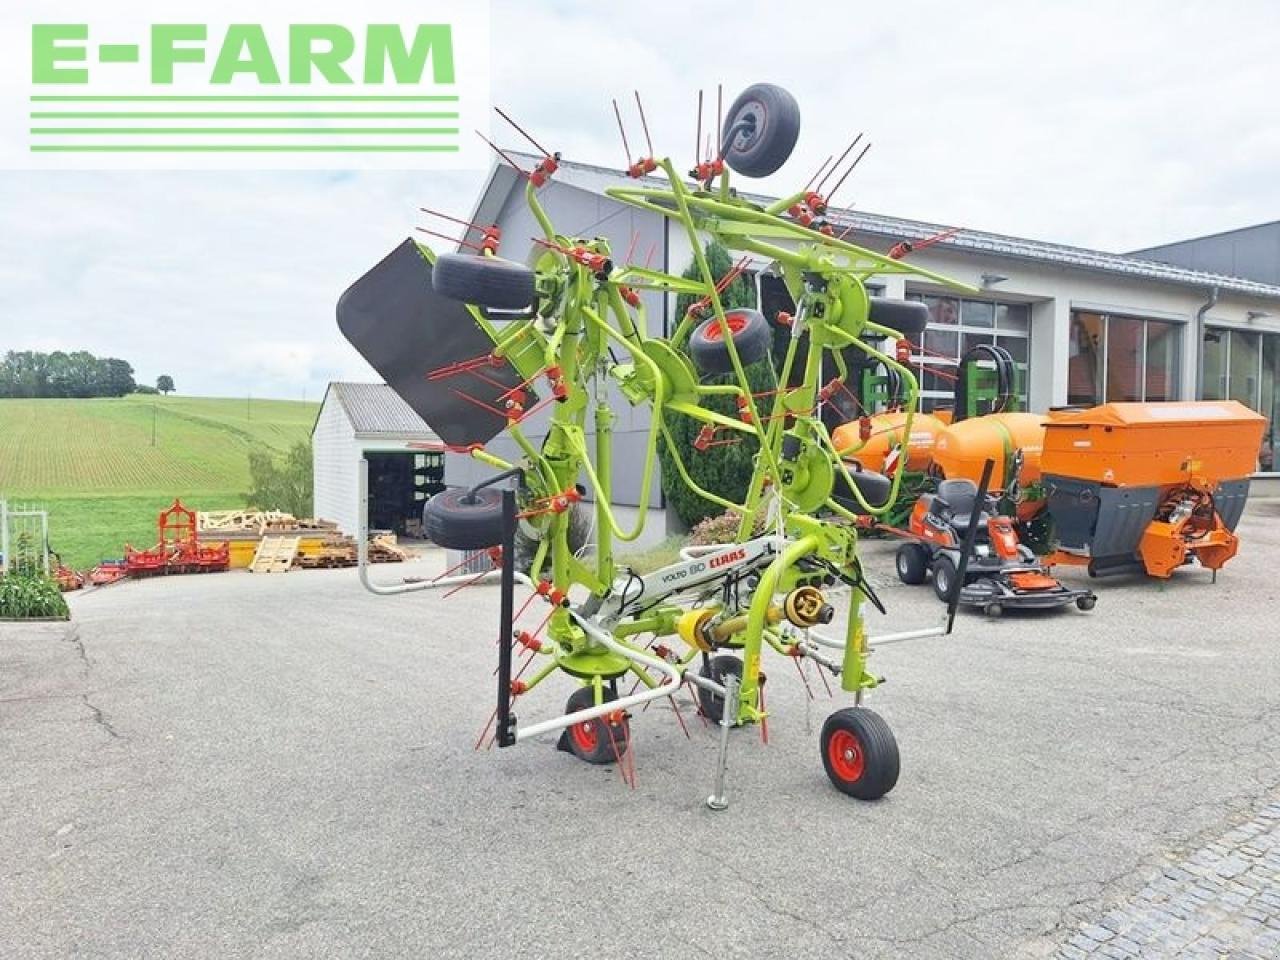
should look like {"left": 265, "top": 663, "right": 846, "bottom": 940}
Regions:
{"left": 896, "top": 479, "right": 1097, "bottom": 617}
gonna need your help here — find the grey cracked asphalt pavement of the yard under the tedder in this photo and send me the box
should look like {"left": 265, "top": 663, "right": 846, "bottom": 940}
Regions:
{"left": 0, "top": 502, "right": 1280, "bottom": 960}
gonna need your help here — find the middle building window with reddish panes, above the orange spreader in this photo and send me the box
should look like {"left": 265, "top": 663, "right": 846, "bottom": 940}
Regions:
{"left": 1066, "top": 310, "right": 1181, "bottom": 407}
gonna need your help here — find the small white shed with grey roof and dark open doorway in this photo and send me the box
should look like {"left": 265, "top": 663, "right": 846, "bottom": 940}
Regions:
{"left": 311, "top": 383, "right": 444, "bottom": 536}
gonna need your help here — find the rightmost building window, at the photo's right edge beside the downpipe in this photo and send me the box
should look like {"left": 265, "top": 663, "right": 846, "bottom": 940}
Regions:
{"left": 1201, "top": 326, "right": 1280, "bottom": 474}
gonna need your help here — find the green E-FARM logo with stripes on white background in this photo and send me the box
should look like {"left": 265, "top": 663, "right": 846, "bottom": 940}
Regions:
{"left": 0, "top": 0, "right": 488, "bottom": 169}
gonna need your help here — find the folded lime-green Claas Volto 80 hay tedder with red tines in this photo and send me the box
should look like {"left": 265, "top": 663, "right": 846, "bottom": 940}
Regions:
{"left": 338, "top": 84, "right": 968, "bottom": 809}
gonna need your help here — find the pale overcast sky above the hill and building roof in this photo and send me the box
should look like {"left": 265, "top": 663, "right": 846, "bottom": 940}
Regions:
{"left": 0, "top": 0, "right": 1280, "bottom": 399}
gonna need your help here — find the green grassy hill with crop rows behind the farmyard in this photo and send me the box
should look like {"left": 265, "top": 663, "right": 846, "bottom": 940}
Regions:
{"left": 0, "top": 396, "right": 319, "bottom": 567}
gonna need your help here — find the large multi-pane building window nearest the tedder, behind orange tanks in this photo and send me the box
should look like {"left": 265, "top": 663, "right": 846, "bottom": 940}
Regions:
{"left": 906, "top": 293, "right": 1032, "bottom": 411}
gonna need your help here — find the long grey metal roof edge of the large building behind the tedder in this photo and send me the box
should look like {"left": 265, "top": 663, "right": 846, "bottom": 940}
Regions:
{"left": 485, "top": 150, "right": 1280, "bottom": 300}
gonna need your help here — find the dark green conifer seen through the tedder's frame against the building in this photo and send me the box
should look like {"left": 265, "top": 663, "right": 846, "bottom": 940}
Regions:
{"left": 658, "top": 241, "right": 776, "bottom": 526}
